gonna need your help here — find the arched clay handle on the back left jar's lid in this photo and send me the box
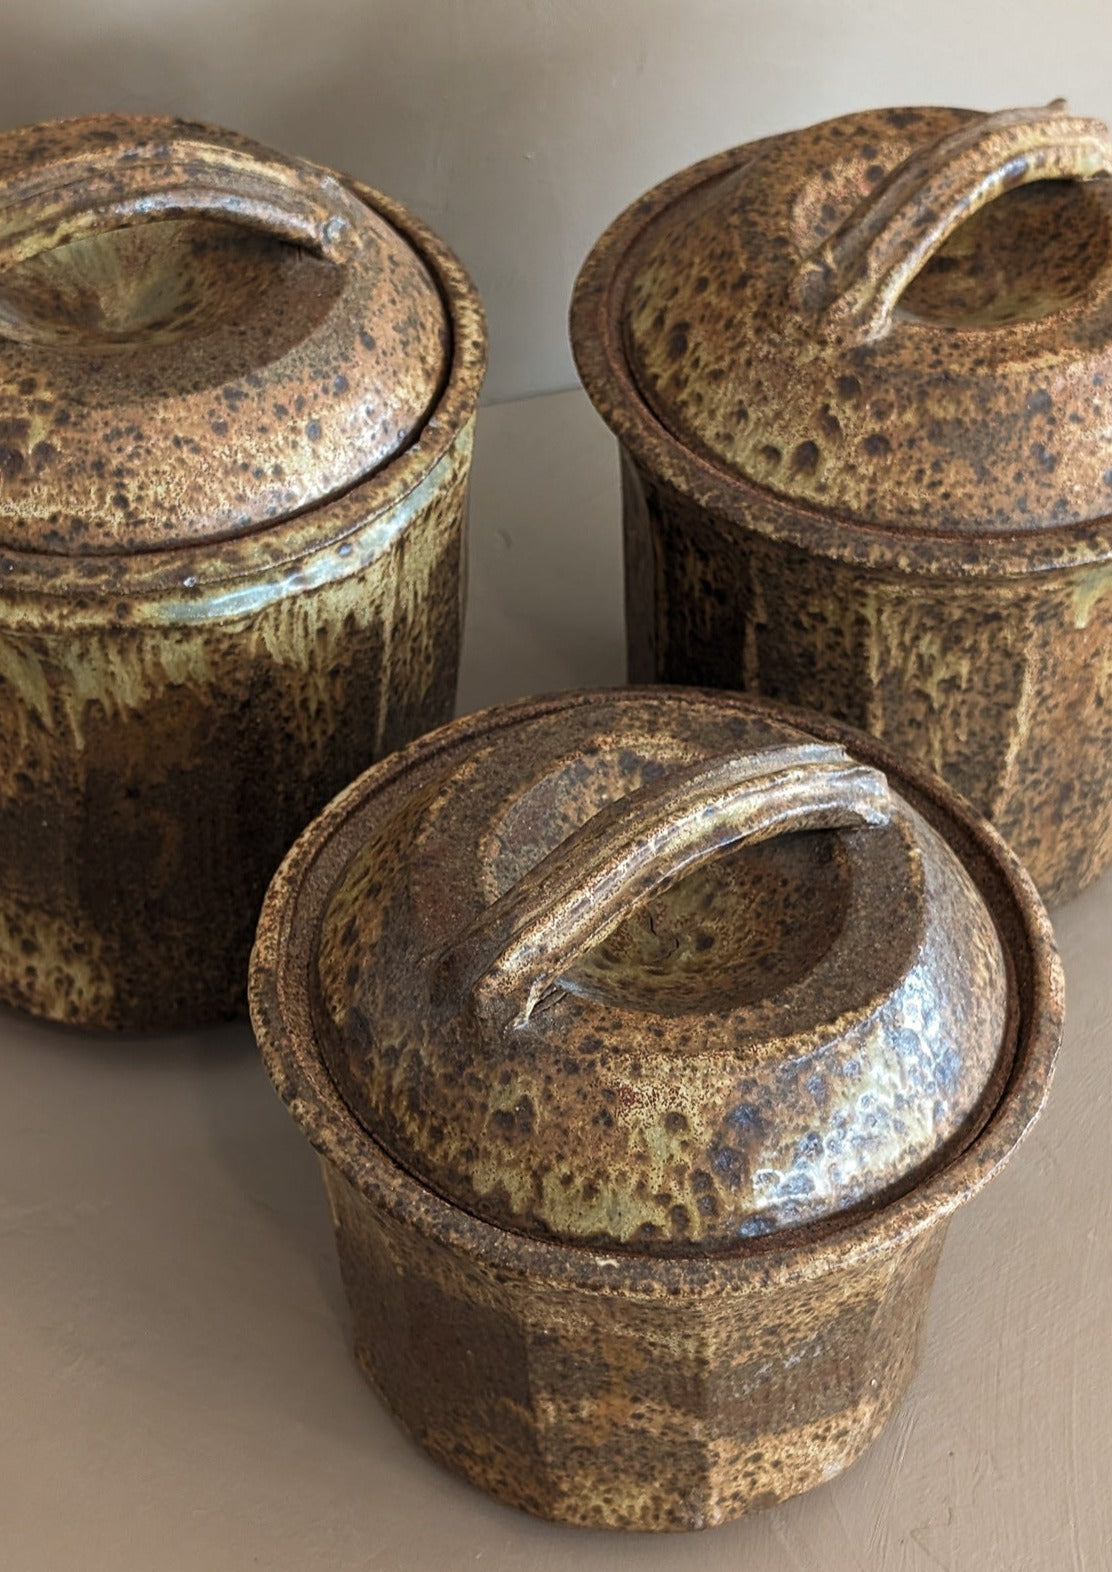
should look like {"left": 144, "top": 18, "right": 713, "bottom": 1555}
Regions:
{"left": 0, "top": 127, "right": 362, "bottom": 269}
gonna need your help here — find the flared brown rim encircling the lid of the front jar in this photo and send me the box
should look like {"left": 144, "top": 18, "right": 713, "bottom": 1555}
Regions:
{"left": 250, "top": 689, "right": 1062, "bottom": 1292}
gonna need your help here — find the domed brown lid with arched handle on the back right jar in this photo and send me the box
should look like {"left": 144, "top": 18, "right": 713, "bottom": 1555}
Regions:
{"left": 616, "top": 102, "right": 1112, "bottom": 536}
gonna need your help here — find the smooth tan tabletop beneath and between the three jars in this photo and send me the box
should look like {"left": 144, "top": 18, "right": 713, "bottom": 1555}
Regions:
{"left": 0, "top": 393, "right": 1112, "bottom": 1572}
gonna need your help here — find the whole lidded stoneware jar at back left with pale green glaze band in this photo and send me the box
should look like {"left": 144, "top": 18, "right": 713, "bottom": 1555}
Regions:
{"left": 0, "top": 116, "right": 484, "bottom": 1028}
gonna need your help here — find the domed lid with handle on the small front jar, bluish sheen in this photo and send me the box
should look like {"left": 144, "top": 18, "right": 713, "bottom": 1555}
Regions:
{"left": 305, "top": 690, "right": 1016, "bottom": 1254}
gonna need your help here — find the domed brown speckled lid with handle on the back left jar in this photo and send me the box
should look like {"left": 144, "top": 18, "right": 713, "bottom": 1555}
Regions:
{"left": 0, "top": 115, "right": 450, "bottom": 556}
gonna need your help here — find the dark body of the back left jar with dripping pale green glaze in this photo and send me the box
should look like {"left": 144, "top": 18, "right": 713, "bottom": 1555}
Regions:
{"left": 0, "top": 420, "right": 473, "bottom": 1030}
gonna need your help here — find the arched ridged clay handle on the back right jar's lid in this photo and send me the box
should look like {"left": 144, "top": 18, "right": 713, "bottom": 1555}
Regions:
{"left": 794, "top": 99, "right": 1112, "bottom": 344}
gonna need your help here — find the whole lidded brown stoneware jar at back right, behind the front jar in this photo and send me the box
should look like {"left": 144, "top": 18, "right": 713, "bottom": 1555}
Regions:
{"left": 571, "top": 104, "right": 1112, "bottom": 899}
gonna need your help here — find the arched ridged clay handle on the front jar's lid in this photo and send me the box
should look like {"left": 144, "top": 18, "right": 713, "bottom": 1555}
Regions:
{"left": 439, "top": 744, "right": 890, "bottom": 1033}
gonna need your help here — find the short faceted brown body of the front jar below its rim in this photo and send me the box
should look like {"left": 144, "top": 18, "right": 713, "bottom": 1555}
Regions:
{"left": 322, "top": 1159, "right": 947, "bottom": 1531}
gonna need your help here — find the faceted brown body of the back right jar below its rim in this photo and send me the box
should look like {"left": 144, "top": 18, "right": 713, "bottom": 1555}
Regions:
{"left": 621, "top": 453, "right": 1112, "bottom": 902}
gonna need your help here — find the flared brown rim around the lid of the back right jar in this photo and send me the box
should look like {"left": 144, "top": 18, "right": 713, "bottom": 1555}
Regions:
{"left": 569, "top": 124, "right": 1112, "bottom": 578}
